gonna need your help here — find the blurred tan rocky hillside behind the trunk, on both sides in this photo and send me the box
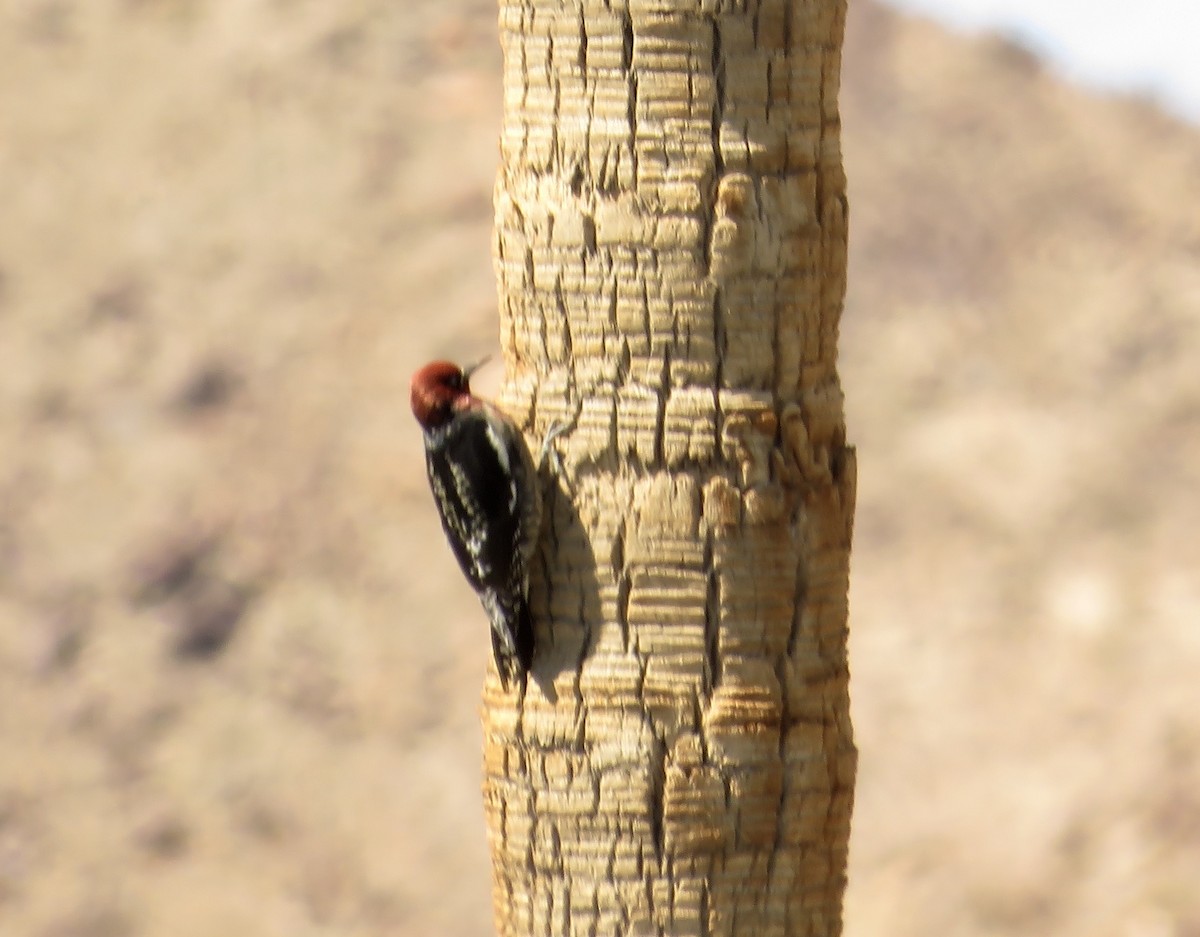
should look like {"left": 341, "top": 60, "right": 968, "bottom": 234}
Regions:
{"left": 0, "top": 0, "right": 1200, "bottom": 937}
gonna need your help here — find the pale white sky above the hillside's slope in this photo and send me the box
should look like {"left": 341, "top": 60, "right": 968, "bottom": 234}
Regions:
{"left": 889, "top": 0, "right": 1200, "bottom": 124}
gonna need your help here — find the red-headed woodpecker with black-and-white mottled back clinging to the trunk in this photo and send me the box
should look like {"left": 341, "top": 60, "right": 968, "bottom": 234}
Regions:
{"left": 409, "top": 361, "right": 541, "bottom": 687}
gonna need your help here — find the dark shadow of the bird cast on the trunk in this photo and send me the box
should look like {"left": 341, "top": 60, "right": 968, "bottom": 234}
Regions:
{"left": 529, "top": 475, "right": 601, "bottom": 703}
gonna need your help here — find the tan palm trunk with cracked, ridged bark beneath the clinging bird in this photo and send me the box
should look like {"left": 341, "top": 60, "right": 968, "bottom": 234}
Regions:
{"left": 484, "top": 0, "right": 856, "bottom": 937}
